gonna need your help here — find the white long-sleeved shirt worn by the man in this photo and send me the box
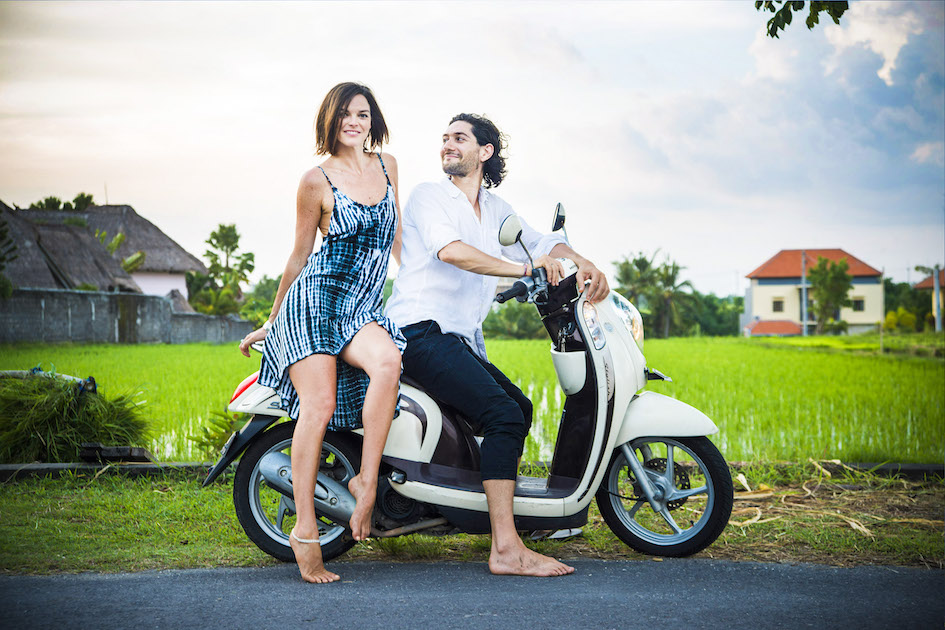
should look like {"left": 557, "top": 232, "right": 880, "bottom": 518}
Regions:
{"left": 385, "top": 178, "right": 565, "bottom": 359}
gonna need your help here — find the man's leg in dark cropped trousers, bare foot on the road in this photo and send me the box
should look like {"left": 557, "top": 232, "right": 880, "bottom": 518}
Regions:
{"left": 404, "top": 325, "right": 574, "bottom": 576}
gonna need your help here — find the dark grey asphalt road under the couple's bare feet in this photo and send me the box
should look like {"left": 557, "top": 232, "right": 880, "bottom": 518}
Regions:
{"left": 0, "top": 559, "right": 945, "bottom": 630}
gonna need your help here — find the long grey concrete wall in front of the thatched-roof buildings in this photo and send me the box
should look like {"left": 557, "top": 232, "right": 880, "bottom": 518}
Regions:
{"left": 0, "top": 289, "right": 253, "bottom": 343}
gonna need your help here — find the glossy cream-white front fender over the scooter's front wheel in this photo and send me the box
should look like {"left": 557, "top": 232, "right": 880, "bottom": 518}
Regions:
{"left": 617, "top": 392, "right": 719, "bottom": 444}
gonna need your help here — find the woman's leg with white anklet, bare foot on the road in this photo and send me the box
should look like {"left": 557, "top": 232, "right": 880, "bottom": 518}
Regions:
{"left": 289, "top": 354, "right": 341, "bottom": 584}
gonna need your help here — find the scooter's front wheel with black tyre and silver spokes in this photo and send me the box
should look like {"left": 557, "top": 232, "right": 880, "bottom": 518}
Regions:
{"left": 596, "top": 437, "right": 733, "bottom": 557}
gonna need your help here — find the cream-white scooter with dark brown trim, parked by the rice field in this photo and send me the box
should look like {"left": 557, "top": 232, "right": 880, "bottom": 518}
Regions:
{"left": 204, "top": 204, "right": 733, "bottom": 562}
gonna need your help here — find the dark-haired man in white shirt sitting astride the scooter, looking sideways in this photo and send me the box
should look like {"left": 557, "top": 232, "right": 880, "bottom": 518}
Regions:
{"left": 387, "top": 114, "right": 609, "bottom": 576}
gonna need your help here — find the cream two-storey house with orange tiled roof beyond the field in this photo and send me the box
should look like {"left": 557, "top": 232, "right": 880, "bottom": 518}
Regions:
{"left": 742, "top": 248, "right": 885, "bottom": 336}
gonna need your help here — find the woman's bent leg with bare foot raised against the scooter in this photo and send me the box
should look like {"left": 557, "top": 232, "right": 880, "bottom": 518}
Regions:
{"left": 341, "top": 322, "right": 400, "bottom": 540}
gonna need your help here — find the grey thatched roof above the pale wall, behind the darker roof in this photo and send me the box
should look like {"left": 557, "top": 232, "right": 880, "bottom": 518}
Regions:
{"left": 17, "top": 206, "right": 207, "bottom": 274}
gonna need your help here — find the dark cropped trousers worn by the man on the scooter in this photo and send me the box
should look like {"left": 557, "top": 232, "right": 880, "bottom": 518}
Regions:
{"left": 401, "top": 320, "right": 532, "bottom": 481}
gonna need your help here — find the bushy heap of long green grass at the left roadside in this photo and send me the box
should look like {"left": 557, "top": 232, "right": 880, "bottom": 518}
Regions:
{"left": 0, "top": 375, "right": 148, "bottom": 464}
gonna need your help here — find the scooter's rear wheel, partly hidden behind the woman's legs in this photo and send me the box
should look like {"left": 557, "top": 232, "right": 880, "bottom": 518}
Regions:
{"left": 233, "top": 422, "right": 361, "bottom": 562}
